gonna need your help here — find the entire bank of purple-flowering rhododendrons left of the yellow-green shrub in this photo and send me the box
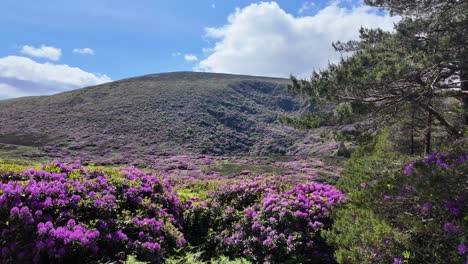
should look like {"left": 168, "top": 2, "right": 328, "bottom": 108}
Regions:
{"left": 0, "top": 158, "right": 345, "bottom": 263}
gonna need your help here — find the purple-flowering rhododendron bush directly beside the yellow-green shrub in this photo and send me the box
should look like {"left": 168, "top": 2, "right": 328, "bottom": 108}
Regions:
{"left": 184, "top": 176, "right": 346, "bottom": 263}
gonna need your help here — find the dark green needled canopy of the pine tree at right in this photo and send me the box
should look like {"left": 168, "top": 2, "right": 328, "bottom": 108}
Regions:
{"left": 290, "top": 0, "right": 468, "bottom": 153}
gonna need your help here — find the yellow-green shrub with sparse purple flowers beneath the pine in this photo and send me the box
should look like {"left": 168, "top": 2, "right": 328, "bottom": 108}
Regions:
{"left": 324, "top": 138, "right": 468, "bottom": 263}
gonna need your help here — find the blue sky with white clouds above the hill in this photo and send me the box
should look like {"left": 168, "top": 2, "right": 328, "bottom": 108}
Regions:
{"left": 0, "top": 0, "right": 399, "bottom": 100}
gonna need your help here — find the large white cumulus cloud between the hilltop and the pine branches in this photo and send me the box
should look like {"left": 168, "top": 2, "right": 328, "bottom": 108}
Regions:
{"left": 194, "top": 2, "right": 398, "bottom": 77}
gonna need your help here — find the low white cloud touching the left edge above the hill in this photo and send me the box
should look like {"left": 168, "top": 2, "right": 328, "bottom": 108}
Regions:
{"left": 0, "top": 56, "right": 112, "bottom": 99}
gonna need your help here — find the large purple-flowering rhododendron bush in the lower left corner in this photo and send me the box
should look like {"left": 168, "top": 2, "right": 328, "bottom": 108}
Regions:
{"left": 0, "top": 161, "right": 184, "bottom": 263}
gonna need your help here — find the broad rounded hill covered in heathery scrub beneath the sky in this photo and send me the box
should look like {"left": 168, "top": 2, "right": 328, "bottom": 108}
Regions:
{"left": 0, "top": 72, "right": 340, "bottom": 163}
